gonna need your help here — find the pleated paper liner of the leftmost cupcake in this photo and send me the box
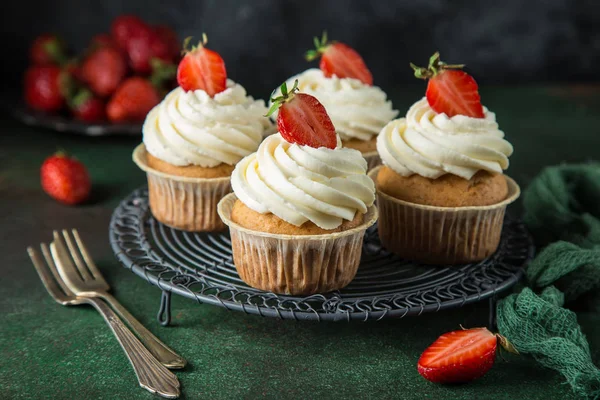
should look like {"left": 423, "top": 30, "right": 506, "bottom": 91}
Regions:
{"left": 133, "top": 144, "right": 231, "bottom": 232}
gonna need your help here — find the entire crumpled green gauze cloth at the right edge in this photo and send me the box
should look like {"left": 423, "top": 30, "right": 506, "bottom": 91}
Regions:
{"left": 497, "top": 163, "right": 600, "bottom": 399}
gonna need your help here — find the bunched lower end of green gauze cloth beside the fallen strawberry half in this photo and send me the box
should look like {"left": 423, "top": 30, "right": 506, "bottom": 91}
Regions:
{"left": 498, "top": 286, "right": 600, "bottom": 399}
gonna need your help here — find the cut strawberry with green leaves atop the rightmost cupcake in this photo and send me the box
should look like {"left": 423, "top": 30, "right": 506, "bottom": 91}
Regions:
{"left": 410, "top": 52, "right": 485, "bottom": 118}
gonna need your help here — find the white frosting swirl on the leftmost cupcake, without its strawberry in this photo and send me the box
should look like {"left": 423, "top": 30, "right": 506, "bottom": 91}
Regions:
{"left": 142, "top": 80, "right": 271, "bottom": 167}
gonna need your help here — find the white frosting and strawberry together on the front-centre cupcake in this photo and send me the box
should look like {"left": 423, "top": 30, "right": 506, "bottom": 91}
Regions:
{"left": 231, "top": 80, "right": 375, "bottom": 229}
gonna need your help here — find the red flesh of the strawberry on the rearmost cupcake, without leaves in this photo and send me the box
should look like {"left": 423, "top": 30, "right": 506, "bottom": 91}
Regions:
{"left": 319, "top": 43, "right": 373, "bottom": 85}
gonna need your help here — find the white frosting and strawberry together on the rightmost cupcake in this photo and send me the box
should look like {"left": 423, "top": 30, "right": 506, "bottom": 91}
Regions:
{"left": 377, "top": 53, "right": 513, "bottom": 179}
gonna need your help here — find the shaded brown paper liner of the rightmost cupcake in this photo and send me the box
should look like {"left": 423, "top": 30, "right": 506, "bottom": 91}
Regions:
{"left": 369, "top": 168, "right": 520, "bottom": 264}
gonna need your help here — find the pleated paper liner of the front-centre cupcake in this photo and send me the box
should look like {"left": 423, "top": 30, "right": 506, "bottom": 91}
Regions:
{"left": 218, "top": 193, "right": 377, "bottom": 295}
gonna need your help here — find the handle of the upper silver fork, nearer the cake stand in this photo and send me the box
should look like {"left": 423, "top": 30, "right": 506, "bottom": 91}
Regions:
{"left": 97, "top": 292, "right": 186, "bottom": 369}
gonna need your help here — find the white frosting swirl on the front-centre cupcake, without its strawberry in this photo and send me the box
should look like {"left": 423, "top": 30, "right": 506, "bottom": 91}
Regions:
{"left": 231, "top": 133, "right": 375, "bottom": 229}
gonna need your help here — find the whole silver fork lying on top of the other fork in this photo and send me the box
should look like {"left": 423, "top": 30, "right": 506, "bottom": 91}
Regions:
{"left": 53, "top": 229, "right": 186, "bottom": 368}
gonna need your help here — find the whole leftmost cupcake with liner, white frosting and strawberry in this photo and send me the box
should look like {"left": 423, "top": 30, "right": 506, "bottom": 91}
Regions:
{"left": 133, "top": 40, "right": 271, "bottom": 231}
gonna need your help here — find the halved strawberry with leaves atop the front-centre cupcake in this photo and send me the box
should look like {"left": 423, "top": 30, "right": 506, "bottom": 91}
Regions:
{"left": 267, "top": 79, "right": 337, "bottom": 149}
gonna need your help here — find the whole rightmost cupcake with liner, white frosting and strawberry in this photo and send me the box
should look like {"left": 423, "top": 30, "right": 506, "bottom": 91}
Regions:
{"left": 370, "top": 53, "right": 520, "bottom": 264}
